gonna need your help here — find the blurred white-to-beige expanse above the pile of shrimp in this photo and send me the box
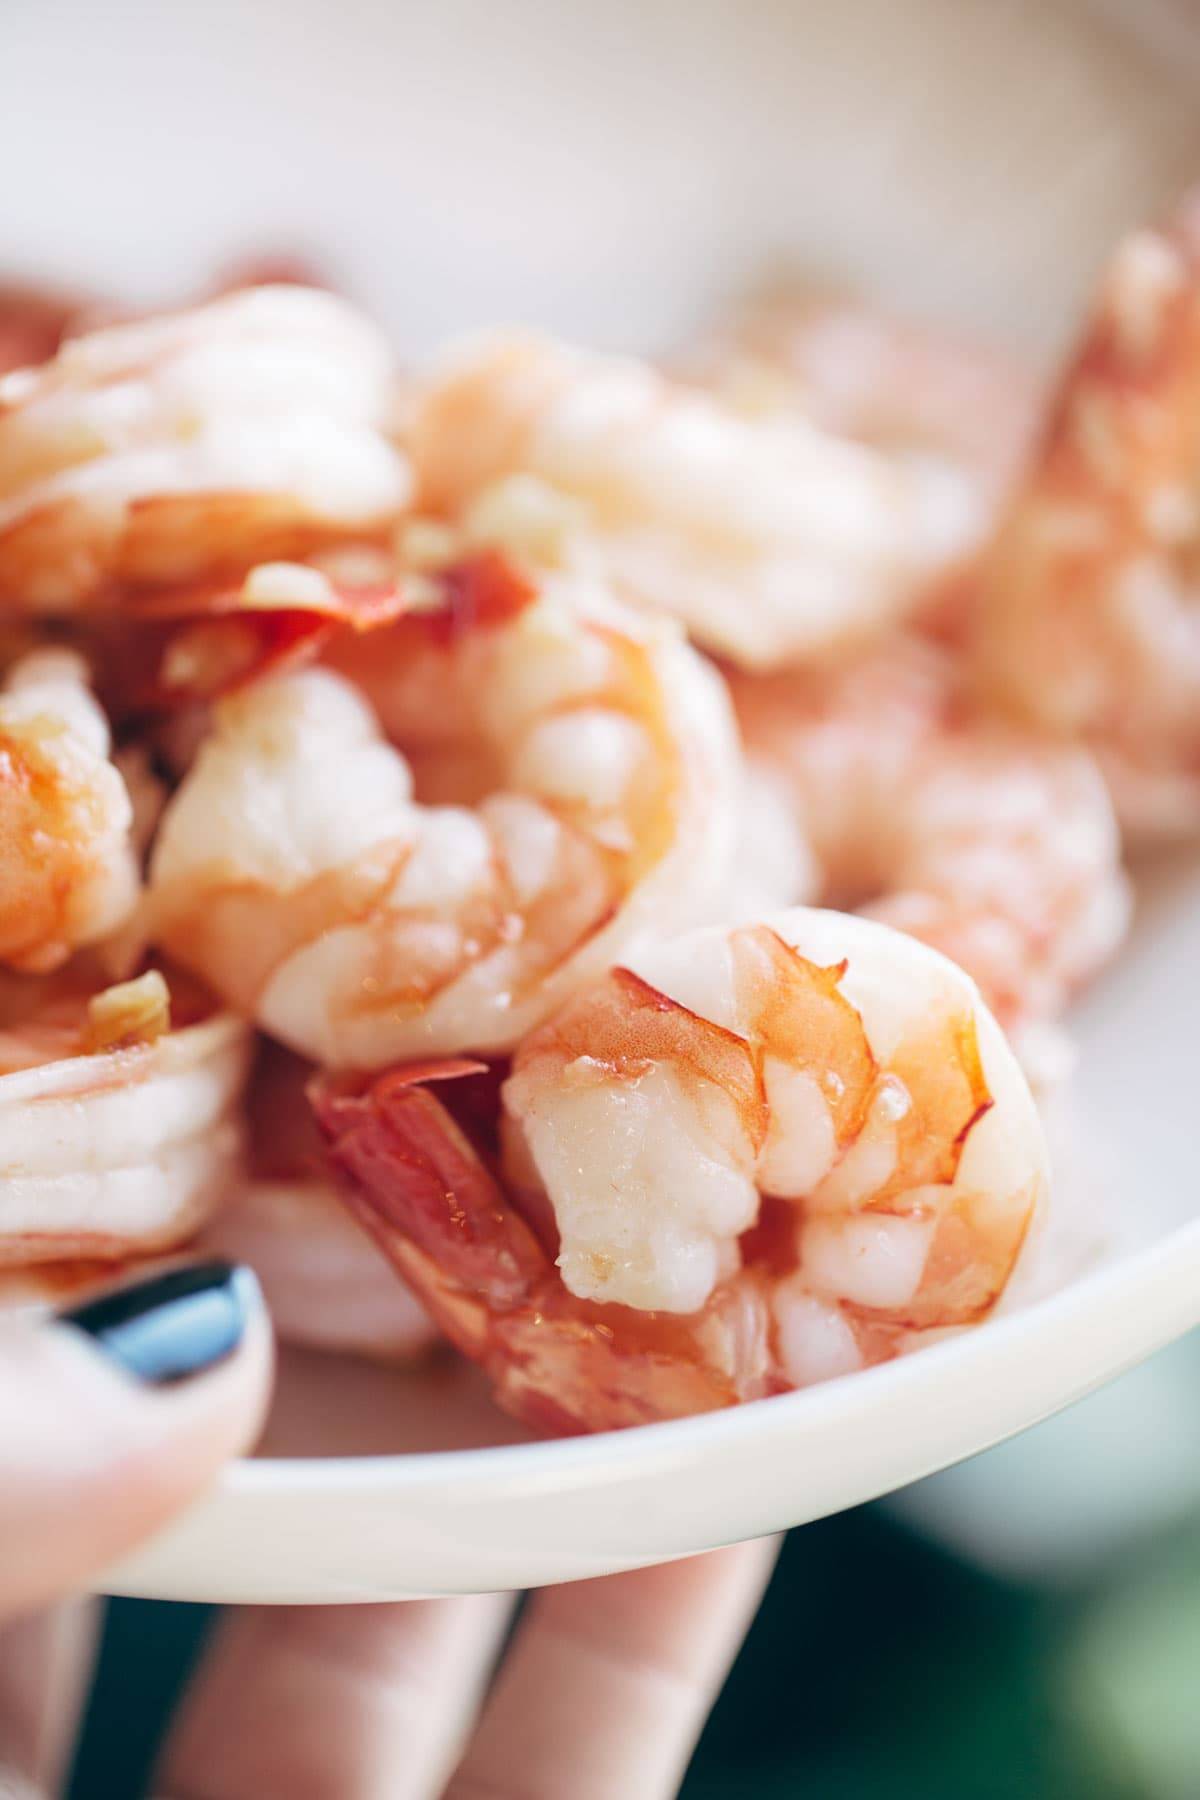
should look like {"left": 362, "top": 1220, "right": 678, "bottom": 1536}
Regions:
{"left": 0, "top": 0, "right": 1200, "bottom": 347}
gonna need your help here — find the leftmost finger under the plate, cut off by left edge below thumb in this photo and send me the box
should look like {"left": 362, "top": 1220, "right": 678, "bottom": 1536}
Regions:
{"left": 0, "top": 1600, "right": 99, "bottom": 1796}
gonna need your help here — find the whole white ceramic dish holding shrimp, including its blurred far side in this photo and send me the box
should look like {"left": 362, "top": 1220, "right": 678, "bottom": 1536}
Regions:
{"left": 0, "top": 0, "right": 1200, "bottom": 1600}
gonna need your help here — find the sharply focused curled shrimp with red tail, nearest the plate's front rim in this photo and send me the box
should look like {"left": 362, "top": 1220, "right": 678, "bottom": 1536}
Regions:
{"left": 313, "top": 909, "right": 1047, "bottom": 1431}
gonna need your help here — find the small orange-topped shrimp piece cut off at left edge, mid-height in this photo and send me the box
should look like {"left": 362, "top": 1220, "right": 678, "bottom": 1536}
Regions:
{"left": 0, "top": 650, "right": 139, "bottom": 972}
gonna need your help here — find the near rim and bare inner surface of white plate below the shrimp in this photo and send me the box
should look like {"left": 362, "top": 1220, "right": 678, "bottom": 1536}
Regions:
{"left": 100, "top": 828, "right": 1200, "bottom": 1602}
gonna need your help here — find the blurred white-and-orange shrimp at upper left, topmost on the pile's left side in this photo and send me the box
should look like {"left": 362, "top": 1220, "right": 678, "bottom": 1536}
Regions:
{"left": 0, "top": 286, "right": 410, "bottom": 612}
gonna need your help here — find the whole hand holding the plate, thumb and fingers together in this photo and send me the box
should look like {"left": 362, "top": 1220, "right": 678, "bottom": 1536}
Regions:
{"left": 0, "top": 1278, "right": 775, "bottom": 1800}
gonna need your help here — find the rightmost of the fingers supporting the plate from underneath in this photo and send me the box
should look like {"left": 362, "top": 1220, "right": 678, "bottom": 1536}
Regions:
{"left": 446, "top": 1539, "right": 779, "bottom": 1800}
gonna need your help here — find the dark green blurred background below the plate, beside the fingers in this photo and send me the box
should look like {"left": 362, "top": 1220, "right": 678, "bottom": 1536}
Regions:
{"left": 72, "top": 1508, "right": 1200, "bottom": 1800}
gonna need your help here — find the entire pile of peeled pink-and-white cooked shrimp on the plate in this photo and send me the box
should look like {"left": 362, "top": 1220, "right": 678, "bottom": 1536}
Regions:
{"left": 0, "top": 179, "right": 1200, "bottom": 1433}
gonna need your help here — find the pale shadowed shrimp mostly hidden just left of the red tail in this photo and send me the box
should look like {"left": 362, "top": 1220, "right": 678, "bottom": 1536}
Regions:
{"left": 198, "top": 1044, "right": 439, "bottom": 1361}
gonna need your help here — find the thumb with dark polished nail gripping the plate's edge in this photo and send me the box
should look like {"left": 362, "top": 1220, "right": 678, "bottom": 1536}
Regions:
{"left": 0, "top": 1264, "right": 272, "bottom": 1618}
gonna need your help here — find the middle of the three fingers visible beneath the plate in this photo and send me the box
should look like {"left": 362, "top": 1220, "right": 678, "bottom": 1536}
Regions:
{"left": 155, "top": 1595, "right": 513, "bottom": 1800}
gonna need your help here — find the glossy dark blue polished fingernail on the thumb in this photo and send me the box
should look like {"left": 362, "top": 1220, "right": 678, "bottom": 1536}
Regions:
{"left": 56, "top": 1262, "right": 261, "bottom": 1388}
